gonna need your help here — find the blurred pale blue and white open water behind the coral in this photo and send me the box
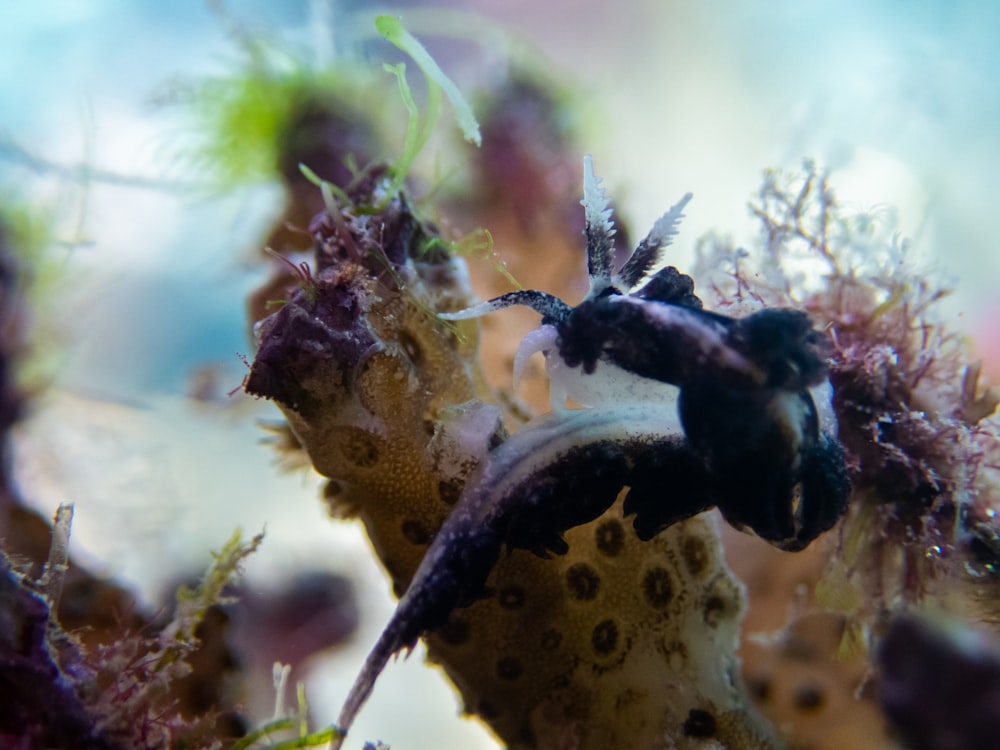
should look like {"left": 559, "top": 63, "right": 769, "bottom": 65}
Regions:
{"left": 0, "top": 0, "right": 1000, "bottom": 747}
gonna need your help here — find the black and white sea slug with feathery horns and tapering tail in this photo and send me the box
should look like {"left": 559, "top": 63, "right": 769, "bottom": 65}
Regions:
{"left": 334, "top": 158, "right": 850, "bottom": 747}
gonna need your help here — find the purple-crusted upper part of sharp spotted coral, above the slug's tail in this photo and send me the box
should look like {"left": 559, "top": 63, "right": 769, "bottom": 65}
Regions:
{"left": 246, "top": 163, "right": 492, "bottom": 587}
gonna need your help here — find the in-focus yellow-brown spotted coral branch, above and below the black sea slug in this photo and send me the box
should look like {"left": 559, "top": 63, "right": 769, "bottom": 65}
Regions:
{"left": 247, "top": 167, "right": 776, "bottom": 748}
